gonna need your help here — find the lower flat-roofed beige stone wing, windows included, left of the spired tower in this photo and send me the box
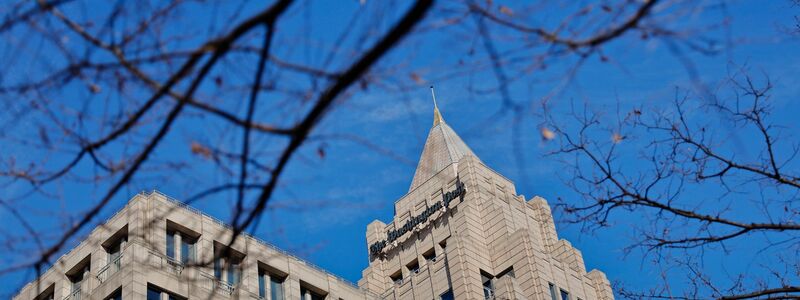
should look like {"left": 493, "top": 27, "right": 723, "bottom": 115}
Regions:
{"left": 13, "top": 192, "right": 375, "bottom": 300}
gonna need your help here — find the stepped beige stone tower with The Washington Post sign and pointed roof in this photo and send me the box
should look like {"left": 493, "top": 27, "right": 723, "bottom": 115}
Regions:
{"left": 359, "top": 98, "right": 613, "bottom": 300}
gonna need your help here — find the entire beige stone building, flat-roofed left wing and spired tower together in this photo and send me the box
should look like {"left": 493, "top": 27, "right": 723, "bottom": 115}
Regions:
{"left": 14, "top": 103, "right": 613, "bottom": 300}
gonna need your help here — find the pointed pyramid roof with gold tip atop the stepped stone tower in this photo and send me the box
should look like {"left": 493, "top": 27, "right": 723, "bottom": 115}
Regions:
{"left": 408, "top": 91, "right": 477, "bottom": 192}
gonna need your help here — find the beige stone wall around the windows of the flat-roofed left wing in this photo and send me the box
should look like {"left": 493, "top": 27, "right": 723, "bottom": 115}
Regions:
{"left": 13, "top": 192, "right": 375, "bottom": 300}
